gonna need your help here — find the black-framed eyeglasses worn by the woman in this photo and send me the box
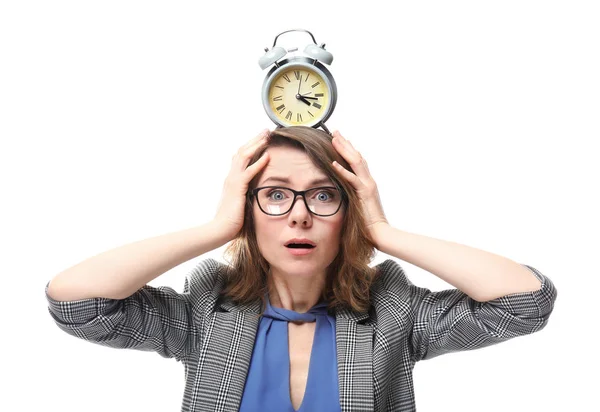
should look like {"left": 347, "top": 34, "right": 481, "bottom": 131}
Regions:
{"left": 248, "top": 186, "right": 345, "bottom": 216}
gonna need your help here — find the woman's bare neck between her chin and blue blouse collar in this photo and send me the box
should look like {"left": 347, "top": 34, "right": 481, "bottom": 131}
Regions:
{"left": 267, "top": 269, "right": 325, "bottom": 313}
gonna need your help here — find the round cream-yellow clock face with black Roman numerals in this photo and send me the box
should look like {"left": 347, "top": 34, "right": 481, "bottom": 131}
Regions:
{"left": 267, "top": 66, "right": 331, "bottom": 125}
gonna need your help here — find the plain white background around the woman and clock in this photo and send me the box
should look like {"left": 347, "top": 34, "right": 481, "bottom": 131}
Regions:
{"left": 0, "top": 0, "right": 600, "bottom": 412}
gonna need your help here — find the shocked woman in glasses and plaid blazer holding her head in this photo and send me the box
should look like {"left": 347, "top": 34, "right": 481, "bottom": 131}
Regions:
{"left": 46, "top": 126, "right": 557, "bottom": 412}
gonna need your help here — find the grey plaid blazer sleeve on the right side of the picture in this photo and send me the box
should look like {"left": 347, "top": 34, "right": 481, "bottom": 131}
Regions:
{"left": 408, "top": 265, "right": 557, "bottom": 362}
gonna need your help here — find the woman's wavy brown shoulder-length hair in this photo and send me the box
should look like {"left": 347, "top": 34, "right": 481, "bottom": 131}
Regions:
{"left": 222, "top": 126, "right": 377, "bottom": 312}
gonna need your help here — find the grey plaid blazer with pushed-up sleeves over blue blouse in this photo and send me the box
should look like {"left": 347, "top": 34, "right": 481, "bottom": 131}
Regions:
{"left": 46, "top": 259, "right": 557, "bottom": 412}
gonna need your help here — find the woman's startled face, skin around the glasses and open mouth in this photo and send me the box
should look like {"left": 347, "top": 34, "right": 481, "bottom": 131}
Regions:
{"left": 252, "top": 147, "right": 345, "bottom": 277}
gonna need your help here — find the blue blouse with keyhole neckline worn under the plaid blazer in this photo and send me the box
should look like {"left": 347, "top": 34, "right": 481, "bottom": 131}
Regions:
{"left": 240, "top": 296, "right": 341, "bottom": 412}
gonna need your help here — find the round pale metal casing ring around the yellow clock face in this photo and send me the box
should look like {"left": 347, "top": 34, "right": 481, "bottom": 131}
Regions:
{"left": 262, "top": 56, "right": 337, "bottom": 131}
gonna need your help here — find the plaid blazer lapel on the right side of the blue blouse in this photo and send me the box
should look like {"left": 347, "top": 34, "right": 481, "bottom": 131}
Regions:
{"left": 335, "top": 310, "right": 374, "bottom": 412}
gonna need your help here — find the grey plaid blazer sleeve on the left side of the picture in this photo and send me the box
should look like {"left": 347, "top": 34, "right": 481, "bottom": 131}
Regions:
{"left": 45, "top": 259, "right": 223, "bottom": 361}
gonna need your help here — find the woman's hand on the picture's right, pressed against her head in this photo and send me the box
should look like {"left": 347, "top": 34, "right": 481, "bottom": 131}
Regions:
{"left": 332, "top": 130, "right": 389, "bottom": 240}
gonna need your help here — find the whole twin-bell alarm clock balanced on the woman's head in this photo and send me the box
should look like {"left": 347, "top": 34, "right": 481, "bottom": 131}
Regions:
{"left": 258, "top": 29, "right": 337, "bottom": 134}
